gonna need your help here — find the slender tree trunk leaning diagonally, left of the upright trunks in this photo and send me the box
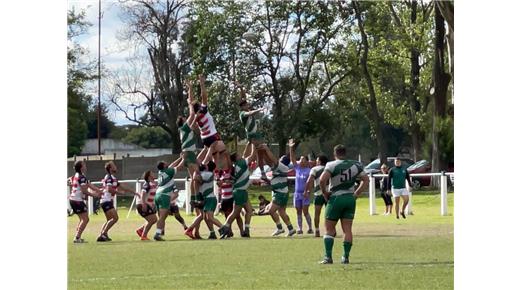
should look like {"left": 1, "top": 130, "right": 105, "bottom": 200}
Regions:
{"left": 352, "top": 1, "right": 387, "bottom": 164}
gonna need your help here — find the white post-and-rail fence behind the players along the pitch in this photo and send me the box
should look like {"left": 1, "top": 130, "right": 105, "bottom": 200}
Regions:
{"left": 67, "top": 172, "right": 454, "bottom": 218}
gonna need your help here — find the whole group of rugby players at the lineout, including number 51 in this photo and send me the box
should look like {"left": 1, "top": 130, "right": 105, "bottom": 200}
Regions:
{"left": 70, "top": 75, "right": 378, "bottom": 264}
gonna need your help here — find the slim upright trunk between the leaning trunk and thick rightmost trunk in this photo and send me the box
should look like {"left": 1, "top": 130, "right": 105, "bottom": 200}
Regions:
{"left": 408, "top": 0, "right": 421, "bottom": 161}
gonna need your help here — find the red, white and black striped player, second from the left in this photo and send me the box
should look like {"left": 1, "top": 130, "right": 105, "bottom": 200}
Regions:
{"left": 97, "top": 161, "right": 137, "bottom": 242}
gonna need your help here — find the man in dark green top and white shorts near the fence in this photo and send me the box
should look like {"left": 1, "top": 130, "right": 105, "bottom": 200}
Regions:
{"left": 386, "top": 157, "right": 413, "bottom": 219}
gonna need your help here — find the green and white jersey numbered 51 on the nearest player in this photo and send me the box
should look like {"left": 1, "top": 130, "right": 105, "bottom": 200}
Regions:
{"left": 325, "top": 160, "right": 366, "bottom": 195}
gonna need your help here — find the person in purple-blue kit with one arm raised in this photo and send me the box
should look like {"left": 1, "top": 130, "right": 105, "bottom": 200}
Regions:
{"left": 289, "top": 139, "right": 314, "bottom": 235}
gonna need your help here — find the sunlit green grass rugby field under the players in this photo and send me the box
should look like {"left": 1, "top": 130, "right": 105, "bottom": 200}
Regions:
{"left": 68, "top": 188, "right": 454, "bottom": 289}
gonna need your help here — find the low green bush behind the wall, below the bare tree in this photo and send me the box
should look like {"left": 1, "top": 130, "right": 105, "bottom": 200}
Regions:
{"left": 123, "top": 127, "right": 172, "bottom": 148}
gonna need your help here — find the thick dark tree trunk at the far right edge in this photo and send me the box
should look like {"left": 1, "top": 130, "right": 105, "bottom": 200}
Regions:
{"left": 432, "top": 5, "right": 451, "bottom": 187}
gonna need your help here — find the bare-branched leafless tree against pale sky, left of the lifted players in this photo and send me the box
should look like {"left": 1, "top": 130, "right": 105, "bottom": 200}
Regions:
{"left": 111, "top": 0, "right": 189, "bottom": 152}
